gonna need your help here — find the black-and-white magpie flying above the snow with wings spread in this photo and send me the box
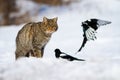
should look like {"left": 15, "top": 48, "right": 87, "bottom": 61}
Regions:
{"left": 78, "top": 19, "right": 111, "bottom": 52}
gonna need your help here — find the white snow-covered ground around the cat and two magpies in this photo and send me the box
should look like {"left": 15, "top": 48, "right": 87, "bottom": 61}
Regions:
{"left": 0, "top": 0, "right": 120, "bottom": 80}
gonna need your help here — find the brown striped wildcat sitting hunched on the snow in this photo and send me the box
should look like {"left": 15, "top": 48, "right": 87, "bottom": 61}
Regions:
{"left": 15, "top": 17, "right": 58, "bottom": 59}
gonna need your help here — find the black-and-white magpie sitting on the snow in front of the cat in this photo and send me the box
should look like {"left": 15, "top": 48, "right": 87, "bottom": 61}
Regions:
{"left": 55, "top": 49, "right": 85, "bottom": 61}
